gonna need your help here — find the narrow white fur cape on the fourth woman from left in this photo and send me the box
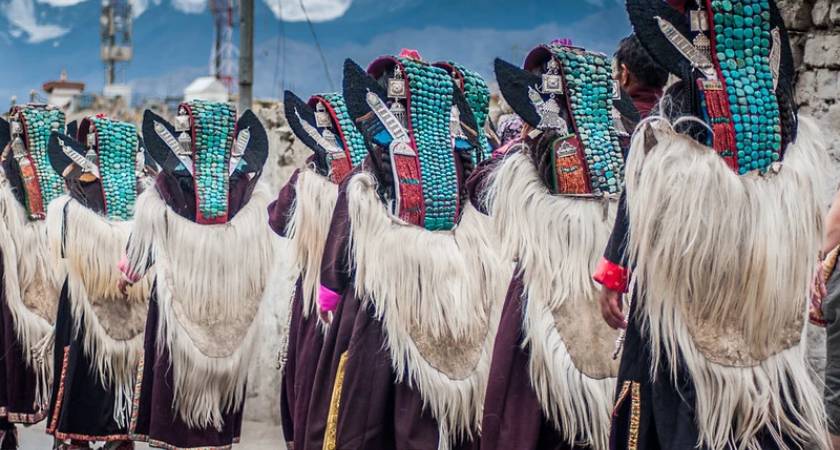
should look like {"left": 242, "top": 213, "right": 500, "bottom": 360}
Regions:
{"left": 286, "top": 168, "right": 338, "bottom": 323}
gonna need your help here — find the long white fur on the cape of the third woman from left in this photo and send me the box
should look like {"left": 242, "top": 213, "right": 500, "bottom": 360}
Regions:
{"left": 132, "top": 185, "right": 288, "bottom": 430}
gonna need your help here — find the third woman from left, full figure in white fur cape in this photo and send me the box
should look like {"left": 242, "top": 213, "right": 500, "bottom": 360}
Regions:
{"left": 120, "top": 100, "right": 278, "bottom": 449}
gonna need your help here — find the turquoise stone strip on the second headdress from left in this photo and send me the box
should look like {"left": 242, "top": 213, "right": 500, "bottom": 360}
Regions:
{"left": 93, "top": 118, "right": 139, "bottom": 220}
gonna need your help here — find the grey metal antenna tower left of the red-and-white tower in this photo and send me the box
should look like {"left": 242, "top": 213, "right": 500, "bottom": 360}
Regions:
{"left": 99, "top": 0, "right": 133, "bottom": 86}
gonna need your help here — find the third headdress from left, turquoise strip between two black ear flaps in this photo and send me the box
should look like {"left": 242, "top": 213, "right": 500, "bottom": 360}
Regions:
{"left": 143, "top": 100, "right": 268, "bottom": 224}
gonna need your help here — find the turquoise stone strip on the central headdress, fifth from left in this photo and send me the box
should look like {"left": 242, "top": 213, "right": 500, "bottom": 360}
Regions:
{"left": 400, "top": 58, "right": 458, "bottom": 230}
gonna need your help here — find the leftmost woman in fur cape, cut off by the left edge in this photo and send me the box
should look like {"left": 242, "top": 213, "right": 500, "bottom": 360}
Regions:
{"left": 0, "top": 104, "right": 65, "bottom": 449}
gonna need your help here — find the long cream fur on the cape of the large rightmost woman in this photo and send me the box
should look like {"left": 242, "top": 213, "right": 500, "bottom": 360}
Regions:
{"left": 627, "top": 118, "right": 829, "bottom": 450}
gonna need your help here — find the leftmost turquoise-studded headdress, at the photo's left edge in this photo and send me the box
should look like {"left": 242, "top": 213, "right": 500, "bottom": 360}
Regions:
{"left": 3, "top": 104, "right": 64, "bottom": 220}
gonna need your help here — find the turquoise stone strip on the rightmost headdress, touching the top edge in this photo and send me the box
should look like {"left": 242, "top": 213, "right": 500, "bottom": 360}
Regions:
{"left": 712, "top": 0, "right": 782, "bottom": 174}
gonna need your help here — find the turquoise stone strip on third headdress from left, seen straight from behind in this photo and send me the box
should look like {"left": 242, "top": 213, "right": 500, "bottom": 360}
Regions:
{"left": 189, "top": 100, "right": 236, "bottom": 219}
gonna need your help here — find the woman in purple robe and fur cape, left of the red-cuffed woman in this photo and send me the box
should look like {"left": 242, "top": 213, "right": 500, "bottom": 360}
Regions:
{"left": 471, "top": 41, "right": 638, "bottom": 450}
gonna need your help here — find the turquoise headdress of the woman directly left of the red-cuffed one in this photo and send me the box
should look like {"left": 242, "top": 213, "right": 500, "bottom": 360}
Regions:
{"left": 495, "top": 42, "right": 627, "bottom": 196}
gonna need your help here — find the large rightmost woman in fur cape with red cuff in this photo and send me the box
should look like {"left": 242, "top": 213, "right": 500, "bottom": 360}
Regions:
{"left": 595, "top": 0, "right": 829, "bottom": 449}
